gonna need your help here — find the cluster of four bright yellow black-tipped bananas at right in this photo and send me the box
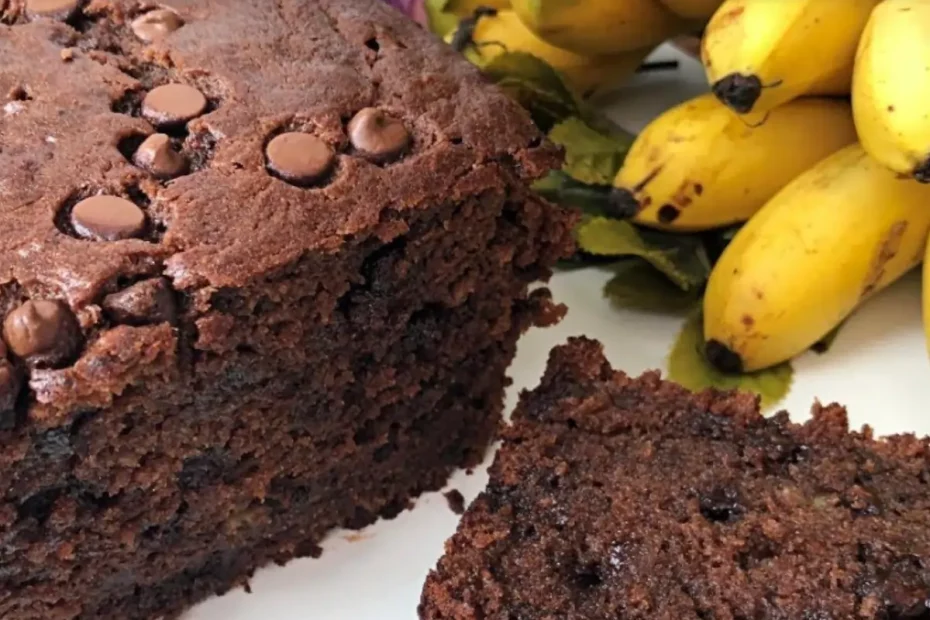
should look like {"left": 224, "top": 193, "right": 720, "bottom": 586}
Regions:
{"left": 684, "top": 0, "right": 930, "bottom": 372}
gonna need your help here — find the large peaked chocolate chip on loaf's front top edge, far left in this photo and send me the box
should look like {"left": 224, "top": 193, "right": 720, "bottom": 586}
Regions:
{"left": 3, "top": 300, "right": 81, "bottom": 366}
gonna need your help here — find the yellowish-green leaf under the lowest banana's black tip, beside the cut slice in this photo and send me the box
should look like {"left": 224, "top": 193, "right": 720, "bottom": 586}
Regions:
{"left": 668, "top": 312, "right": 794, "bottom": 409}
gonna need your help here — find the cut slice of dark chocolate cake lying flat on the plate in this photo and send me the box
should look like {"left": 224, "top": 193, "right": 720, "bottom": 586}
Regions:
{"left": 420, "top": 339, "right": 930, "bottom": 620}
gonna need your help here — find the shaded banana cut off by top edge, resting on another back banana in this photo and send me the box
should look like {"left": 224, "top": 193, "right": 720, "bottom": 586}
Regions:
{"left": 511, "top": 0, "right": 687, "bottom": 56}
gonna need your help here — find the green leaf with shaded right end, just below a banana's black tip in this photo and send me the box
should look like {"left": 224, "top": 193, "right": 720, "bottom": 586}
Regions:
{"left": 575, "top": 216, "right": 710, "bottom": 291}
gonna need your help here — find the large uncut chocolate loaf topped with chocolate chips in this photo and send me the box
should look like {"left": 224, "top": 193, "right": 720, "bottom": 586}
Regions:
{"left": 0, "top": 0, "right": 574, "bottom": 620}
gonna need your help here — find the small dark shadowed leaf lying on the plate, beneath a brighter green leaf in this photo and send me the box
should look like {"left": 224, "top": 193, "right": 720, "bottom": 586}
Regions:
{"left": 604, "top": 258, "right": 700, "bottom": 314}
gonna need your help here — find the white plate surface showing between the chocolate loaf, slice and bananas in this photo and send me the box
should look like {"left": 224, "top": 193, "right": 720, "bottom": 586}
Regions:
{"left": 184, "top": 48, "right": 930, "bottom": 620}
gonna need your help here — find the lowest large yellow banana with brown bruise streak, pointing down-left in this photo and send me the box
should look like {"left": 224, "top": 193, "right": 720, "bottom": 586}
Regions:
{"left": 704, "top": 144, "right": 930, "bottom": 372}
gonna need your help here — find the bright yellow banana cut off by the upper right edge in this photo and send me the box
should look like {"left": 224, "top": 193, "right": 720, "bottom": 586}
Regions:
{"left": 853, "top": 0, "right": 930, "bottom": 183}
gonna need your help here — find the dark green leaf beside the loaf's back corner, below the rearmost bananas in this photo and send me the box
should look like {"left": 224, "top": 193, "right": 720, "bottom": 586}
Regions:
{"left": 484, "top": 52, "right": 578, "bottom": 131}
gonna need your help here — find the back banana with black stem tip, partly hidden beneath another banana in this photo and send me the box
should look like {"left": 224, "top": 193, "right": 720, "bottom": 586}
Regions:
{"left": 446, "top": 11, "right": 650, "bottom": 97}
